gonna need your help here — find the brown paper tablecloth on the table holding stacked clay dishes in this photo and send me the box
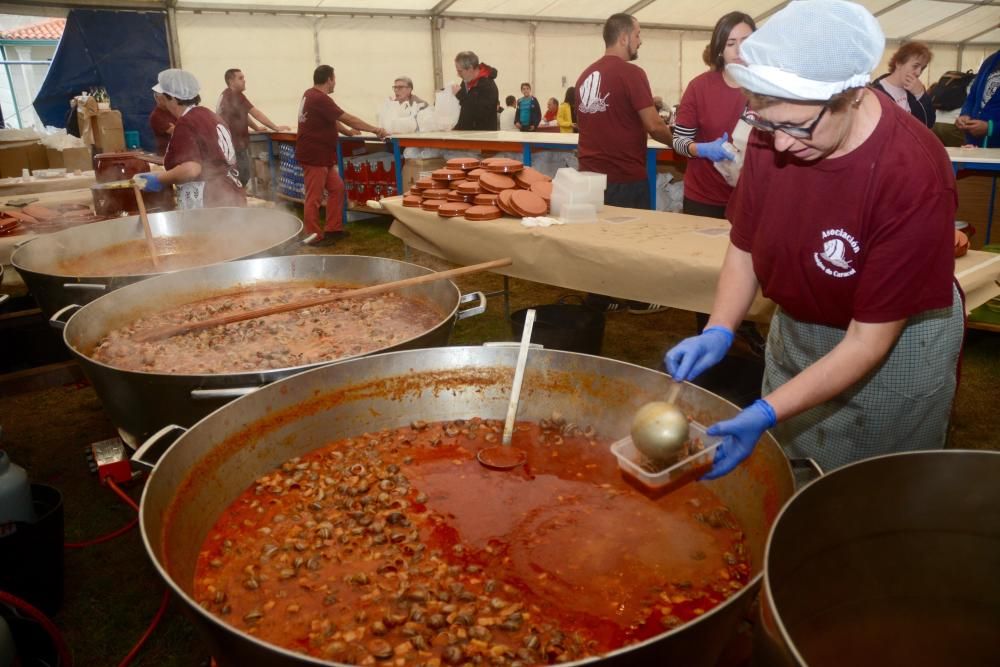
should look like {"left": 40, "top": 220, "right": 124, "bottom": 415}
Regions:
{"left": 382, "top": 197, "right": 1000, "bottom": 322}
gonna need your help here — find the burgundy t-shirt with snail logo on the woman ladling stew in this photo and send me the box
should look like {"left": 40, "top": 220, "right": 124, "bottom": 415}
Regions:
{"left": 727, "top": 95, "right": 957, "bottom": 328}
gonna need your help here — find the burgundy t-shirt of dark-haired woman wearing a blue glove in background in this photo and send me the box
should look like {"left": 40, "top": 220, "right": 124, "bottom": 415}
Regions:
{"left": 677, "top": 71, "right": 747, "bottom": 206}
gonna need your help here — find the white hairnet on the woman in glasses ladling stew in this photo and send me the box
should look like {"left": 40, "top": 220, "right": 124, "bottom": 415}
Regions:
{"left": 726, "top": 0, "right": 885, "bottom": 100}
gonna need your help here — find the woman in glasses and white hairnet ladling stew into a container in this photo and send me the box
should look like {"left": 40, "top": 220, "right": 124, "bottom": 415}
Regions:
{"left": 666, "top": 0, "right": 963, "bottom": 478}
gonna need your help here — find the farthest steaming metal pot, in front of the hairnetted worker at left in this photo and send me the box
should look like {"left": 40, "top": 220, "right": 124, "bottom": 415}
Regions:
{"left": 11, "top": 208, "right": 302, "bottom": 316}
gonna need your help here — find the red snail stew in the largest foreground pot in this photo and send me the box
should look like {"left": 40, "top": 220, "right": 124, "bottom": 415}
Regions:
{"left": 194, "top": 415, "right": 750, "bottom": 666}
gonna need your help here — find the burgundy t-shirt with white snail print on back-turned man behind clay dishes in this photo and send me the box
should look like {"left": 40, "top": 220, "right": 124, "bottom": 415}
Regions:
{"left": 576, "top": 56, "right": 653, "bottom": 183}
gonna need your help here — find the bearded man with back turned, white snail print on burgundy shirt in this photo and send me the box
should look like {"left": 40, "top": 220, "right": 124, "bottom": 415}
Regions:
{"left": 576, "top": 14, "right": 673, "bottom": 314}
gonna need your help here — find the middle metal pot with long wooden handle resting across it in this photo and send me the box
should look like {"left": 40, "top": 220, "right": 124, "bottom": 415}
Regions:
{"left": 53, "top": 255, "right": 486, "bottom": 445}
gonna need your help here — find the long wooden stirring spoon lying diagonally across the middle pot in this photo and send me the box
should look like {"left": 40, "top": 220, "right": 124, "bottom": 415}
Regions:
{"left": 132, "top": 257, "right": 513, "bottom": 343}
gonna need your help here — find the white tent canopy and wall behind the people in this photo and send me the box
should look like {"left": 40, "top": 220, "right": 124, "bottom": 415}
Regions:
{"left": 0, "top": 0, "right": 1000, "bottom": 125}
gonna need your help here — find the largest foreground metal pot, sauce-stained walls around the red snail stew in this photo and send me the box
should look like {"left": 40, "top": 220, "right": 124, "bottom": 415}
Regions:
{"left": 136, "top": 345, "right": 793, "bottom": 667}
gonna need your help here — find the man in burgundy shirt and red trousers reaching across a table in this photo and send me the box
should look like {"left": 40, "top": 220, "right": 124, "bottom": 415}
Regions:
{"left": 295, "top": 65, "right": 386, "bottom": 245}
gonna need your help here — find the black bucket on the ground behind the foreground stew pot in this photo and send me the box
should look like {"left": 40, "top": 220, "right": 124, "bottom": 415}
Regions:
{"left": 510, "top": 297, "right": 604, "bottom": 355}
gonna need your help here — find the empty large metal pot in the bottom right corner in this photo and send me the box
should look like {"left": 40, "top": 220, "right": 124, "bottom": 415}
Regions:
{"left": 754, "top": 450, "right": 1000, "bottom": 667}
